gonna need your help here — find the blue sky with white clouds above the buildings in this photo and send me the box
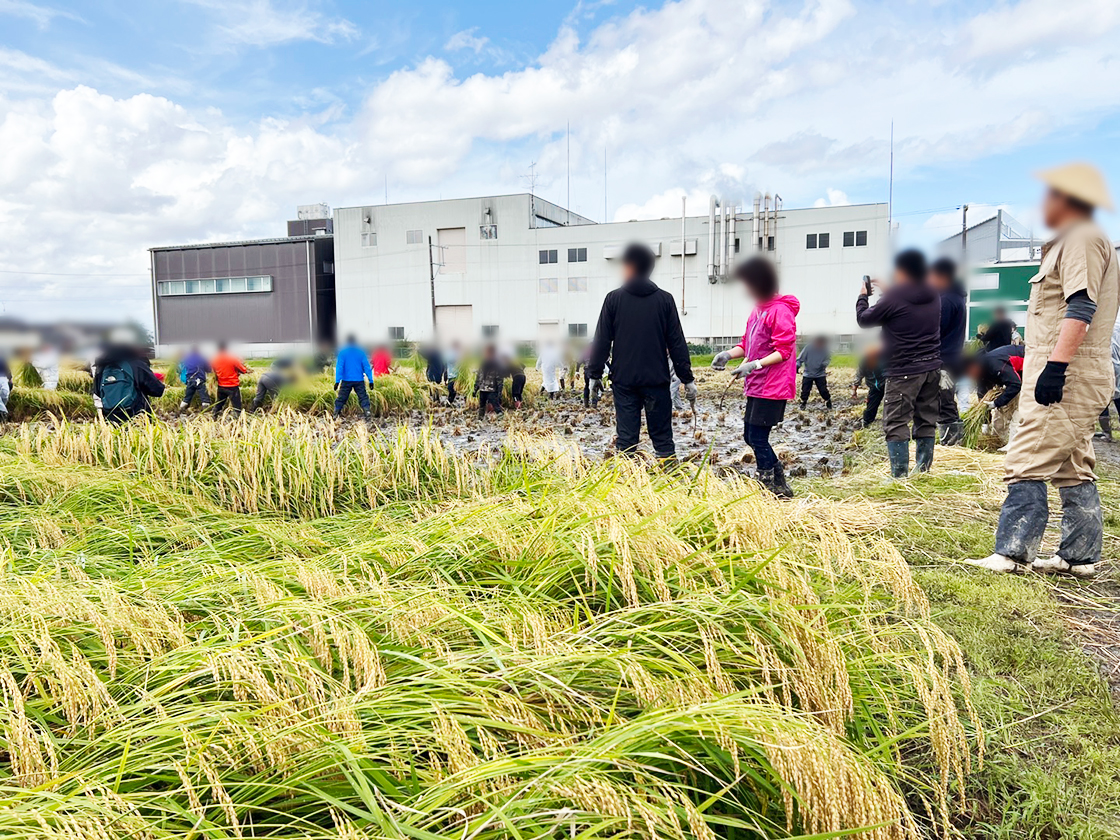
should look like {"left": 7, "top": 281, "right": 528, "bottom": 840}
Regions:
{"left": 0, "top": 0, "right": 1120, "bottom": 324}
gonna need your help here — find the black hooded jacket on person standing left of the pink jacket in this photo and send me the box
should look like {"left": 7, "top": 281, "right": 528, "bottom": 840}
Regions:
{"left": 587, "top": 279, "right": 693, "bottom": 388}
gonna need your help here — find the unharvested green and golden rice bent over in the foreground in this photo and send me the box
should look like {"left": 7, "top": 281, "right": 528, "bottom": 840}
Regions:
{"left": 0, "top": 413, "right": 983, "bottom": 840}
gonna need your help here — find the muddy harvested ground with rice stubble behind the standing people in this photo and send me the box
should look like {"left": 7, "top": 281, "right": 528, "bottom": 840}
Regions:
{"left": 362, "top": 390, "right": 862, "bottom": 476}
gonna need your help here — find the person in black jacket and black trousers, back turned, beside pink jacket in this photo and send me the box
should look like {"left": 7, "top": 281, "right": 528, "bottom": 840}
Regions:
{"left": 587, "top": 243, "right": 697, "bottom": 459}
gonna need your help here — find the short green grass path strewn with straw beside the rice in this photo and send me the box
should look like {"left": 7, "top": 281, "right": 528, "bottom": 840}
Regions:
{"left": 810, "top": 438, "right": 1120, "bottom": 840}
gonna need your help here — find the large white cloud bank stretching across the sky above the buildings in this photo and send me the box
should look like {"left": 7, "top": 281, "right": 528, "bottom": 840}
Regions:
{"left": 0, "top": 0, "right": 1120, "bottom": 317}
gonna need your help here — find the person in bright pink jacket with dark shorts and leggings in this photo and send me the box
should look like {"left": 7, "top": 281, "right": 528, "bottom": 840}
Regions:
{"left": 711, "top": 256, "right": 801, "bottom": 498}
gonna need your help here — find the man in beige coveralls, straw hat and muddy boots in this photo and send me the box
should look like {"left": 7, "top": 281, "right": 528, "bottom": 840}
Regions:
{"left": 970, "top": 164, "right": 1120, "bottom": 577}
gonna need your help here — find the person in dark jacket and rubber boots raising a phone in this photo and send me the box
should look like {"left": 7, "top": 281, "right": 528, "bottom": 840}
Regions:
{"left": 856, "top": 250, "right": 941, "bottom": 478}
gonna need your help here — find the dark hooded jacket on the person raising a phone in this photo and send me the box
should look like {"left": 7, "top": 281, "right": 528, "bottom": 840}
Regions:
{"left": 856, "top": 283, "right": 941, "bottom": 376}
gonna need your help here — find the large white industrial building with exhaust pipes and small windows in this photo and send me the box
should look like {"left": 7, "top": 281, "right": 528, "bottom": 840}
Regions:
{"left": 334, "top": 194, "right": 889, "bottom": 346}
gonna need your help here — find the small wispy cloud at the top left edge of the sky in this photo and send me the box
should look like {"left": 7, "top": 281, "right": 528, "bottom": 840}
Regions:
{"left": 185, "top": 0, "right": 360, "bottom": 47}
